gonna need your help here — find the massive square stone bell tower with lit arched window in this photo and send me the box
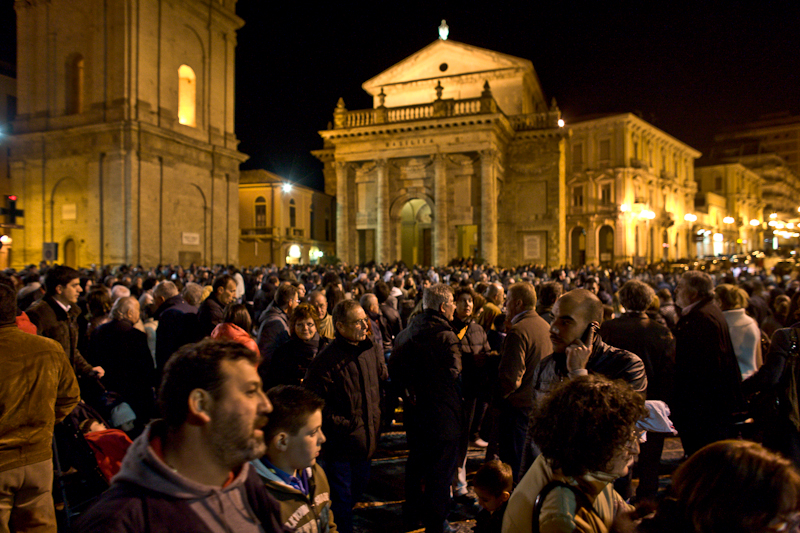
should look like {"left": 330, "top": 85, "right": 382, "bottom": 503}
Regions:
{"left": 10, "top": 0, "right": 246, "bottom": 267}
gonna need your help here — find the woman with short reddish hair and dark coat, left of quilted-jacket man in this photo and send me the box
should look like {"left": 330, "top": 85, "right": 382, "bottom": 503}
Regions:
{"left": 261, "top": 304, "right": 330, "bottom": 390}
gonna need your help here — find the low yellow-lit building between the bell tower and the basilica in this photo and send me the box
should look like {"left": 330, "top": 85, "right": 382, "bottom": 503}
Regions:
{"left": 239, "top": 170, "right": 336, "bottom": 266}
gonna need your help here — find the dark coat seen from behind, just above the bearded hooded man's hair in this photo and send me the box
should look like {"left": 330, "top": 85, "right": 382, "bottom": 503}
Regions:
{"left": 153, "top": 294, "right": 200, "bottom": 374}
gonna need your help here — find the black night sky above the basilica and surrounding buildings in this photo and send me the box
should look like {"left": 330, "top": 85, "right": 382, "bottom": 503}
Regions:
{"left": 0, "top": 0, "right": 800, "bottom": 191}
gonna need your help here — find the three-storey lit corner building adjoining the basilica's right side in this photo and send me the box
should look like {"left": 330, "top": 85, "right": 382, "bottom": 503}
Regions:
{"left": 566, "top": 113, "right": 701, "bottom": 266}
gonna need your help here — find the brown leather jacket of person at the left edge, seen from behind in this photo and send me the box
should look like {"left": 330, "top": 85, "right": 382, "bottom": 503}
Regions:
{"left": 0, "top": 324, "right": 80, "bottom": 472}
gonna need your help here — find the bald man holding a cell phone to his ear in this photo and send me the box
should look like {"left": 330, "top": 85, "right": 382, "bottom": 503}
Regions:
{"left": 520, "top": 289, "right": 647, "bottom": 474}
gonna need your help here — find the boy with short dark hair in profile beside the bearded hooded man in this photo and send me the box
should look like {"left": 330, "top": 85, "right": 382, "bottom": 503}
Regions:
{"left": 252, "top": 385, "right": 336, "bottom": 533}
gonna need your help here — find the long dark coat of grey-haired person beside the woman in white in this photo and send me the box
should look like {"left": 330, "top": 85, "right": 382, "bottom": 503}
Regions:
{"left": 670, "top": 297, "right": 744, "bottom": 446}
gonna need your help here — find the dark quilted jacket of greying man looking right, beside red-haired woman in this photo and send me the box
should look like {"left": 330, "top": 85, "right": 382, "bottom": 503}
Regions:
{"left": 303, "top": 333, "right": 385, "bottom": 461}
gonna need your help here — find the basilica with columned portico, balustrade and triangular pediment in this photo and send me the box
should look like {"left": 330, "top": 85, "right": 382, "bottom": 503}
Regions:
{"left": 313, "top": 39, "right": 568, "bottom": 266}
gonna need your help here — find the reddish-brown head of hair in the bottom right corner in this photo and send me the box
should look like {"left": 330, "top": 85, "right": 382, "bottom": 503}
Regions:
{"left": 638, "top": 440, "right": 800, "bottom": 533}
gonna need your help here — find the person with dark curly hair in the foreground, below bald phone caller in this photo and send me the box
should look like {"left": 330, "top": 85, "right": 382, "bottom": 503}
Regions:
{"left": 503, "top": 375, "right": 647, "bottom": 533}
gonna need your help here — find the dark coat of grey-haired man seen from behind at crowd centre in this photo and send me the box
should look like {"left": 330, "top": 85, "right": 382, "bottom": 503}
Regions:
{"left": 389, "top": 309, "right": 464, "bottom": 440}
